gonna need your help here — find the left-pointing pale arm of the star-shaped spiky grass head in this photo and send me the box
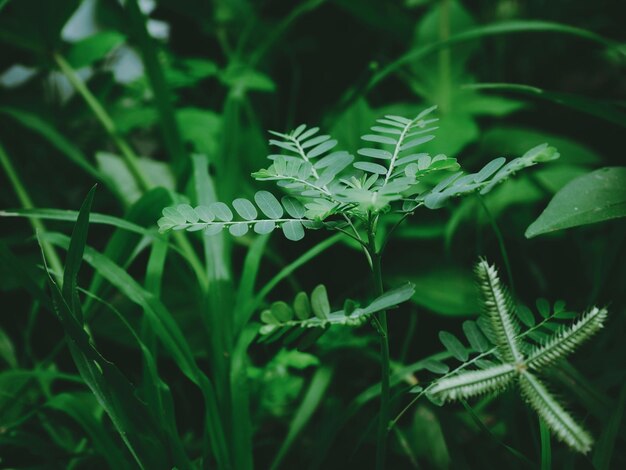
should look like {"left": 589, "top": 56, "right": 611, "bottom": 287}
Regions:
{"left": 430, "top": 364, "right": 516, "bottom": 401}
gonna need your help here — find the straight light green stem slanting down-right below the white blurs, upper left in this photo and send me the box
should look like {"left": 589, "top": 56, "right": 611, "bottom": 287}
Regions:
{"left": 53, "top": 53, "right": 152, "bottom": 192}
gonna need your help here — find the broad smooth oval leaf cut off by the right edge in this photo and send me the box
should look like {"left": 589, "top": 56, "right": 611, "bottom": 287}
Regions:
{"left": 525, "top": 167, "right": 626, "bottom": 238}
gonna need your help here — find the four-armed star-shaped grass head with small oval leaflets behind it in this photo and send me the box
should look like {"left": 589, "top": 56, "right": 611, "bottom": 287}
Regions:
{"left": 424, "top": 260, "right": 608, "bottom": 453}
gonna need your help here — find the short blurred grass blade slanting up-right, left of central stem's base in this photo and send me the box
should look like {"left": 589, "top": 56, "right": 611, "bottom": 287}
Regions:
{"left": 270, "top": 367, "right": 333, "bottom": 470}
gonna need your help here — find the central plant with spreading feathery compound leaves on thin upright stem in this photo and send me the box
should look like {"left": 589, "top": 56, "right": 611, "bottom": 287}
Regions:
{"left": 158, "top": 107, "right": 559, "bottom": 468}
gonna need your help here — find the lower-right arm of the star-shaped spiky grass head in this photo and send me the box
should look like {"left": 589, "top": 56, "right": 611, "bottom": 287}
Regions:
{"left": 519, "top": 371, "right": 593, "bottom": 454}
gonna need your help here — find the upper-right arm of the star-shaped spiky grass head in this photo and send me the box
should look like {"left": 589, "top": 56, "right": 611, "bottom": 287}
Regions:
{"left": 526, "top": 307, "right": 608, "bottom": 370}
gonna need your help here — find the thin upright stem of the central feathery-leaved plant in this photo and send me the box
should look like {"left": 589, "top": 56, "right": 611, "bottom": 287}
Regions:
{"left": 367, "top": 219, "right": 390, "bottom": 470}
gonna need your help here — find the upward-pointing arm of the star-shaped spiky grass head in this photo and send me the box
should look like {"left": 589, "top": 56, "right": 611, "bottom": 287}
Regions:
{"left": 475, "top": 259, "right": 523, "bottom": 363}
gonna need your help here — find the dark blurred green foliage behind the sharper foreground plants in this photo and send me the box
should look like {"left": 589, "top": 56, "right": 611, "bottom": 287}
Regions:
{"left": 0, "top": 0, "right": 626, "bottom": 468}
